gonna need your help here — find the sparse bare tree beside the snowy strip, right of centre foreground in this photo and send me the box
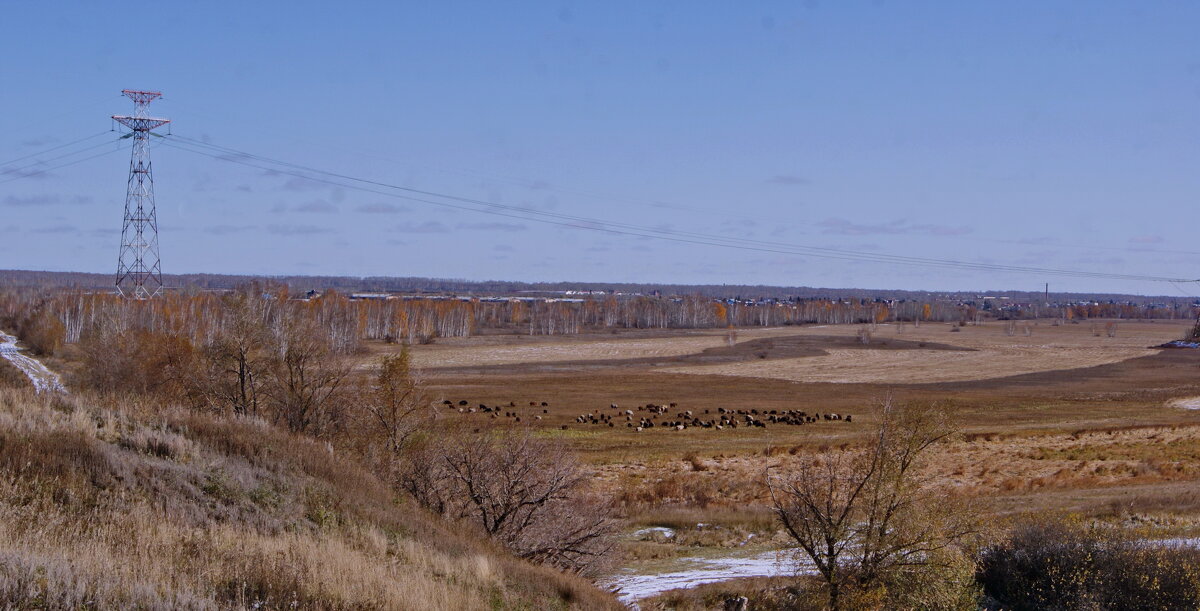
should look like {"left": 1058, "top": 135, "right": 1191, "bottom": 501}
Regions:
{"left": 767, "top": 401, "right": 978, "bottom": 611}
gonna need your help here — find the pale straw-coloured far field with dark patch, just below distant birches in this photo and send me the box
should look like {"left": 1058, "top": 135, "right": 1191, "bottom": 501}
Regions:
{"left": 414, "top": 322, "right": 1182, "bottom": 384}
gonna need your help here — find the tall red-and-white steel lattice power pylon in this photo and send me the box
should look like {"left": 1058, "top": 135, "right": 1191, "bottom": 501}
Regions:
{"left": 113, "top": 89, "right": 170, "bottom": 299}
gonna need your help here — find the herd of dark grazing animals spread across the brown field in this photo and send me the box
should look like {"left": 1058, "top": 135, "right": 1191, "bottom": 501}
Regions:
{"left": 443, "top": 400, "right": 854, "bottom": 432}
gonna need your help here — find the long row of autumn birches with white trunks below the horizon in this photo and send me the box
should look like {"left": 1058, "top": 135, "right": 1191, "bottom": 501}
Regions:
{"left": 0, "top": 282, "right": 1198, "bottom": 354}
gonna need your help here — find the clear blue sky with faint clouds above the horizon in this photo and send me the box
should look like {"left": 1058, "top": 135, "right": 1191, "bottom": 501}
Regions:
{"left": 0, "top": 1, "right": 1200, "bottom": 295}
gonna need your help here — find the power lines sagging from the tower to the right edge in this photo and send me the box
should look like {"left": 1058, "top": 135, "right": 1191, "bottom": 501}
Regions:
{"left": 164, "top": 136, "right": 1198, "bottom": 282}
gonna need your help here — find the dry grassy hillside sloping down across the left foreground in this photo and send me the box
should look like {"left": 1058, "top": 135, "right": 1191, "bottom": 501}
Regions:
{"left": 0, "top": 389, "right": 619, "bottom": 610}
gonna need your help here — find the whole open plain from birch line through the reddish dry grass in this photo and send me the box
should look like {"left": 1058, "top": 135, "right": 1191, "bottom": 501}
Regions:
{"left": 396, "top": 321, "right": 1200, "bottom": 511}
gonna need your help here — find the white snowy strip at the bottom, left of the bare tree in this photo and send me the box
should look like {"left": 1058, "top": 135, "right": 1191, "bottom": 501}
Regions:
{"left": 600, "top": 550, "right": 810, "bottom": 609}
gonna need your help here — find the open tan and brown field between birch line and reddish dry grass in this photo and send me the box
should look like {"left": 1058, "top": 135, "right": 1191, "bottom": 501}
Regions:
{"left": 400, "top": 322, "right": 1200, "bottom": 456}
